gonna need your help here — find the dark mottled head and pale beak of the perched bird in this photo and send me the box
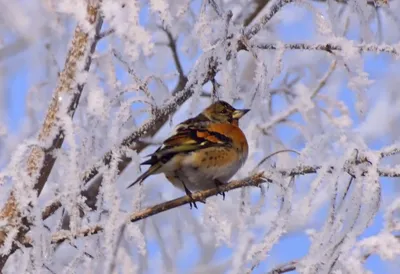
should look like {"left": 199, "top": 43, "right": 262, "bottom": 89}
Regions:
{"left": 203, "top": 101, "right": 250, "bottom": 125}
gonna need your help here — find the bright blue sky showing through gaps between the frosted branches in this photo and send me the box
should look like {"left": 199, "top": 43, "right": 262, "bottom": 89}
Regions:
{"left": 1, "top": 1, "right": 397, "bottom": 273}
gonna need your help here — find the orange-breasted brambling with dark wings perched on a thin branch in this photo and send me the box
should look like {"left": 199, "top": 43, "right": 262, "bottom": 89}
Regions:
{"left": 128, "top": 101, "right": 249, "bottom": 208}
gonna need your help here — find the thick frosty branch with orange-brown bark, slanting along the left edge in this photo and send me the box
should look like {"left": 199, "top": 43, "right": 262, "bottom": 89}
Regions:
{"left": 0, "top": 3, "right": 103, "bottom": 271}
